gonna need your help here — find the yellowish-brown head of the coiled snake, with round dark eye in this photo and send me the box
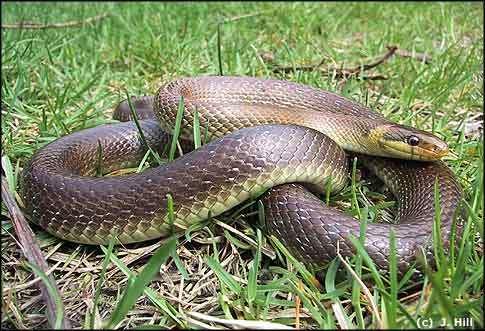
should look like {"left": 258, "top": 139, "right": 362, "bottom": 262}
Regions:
{"left": 371, "top": 124, "right": 449, "bottom": 161}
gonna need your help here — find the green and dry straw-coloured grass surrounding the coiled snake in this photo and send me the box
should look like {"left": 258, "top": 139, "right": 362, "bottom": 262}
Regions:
{"left": 1, "top": 3, "right": 483, "bottom": 328}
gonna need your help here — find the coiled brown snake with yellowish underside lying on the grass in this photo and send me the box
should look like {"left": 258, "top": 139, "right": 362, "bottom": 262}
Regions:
{"left": 21, "top": 76, "right": 463, "bottom": 271}
